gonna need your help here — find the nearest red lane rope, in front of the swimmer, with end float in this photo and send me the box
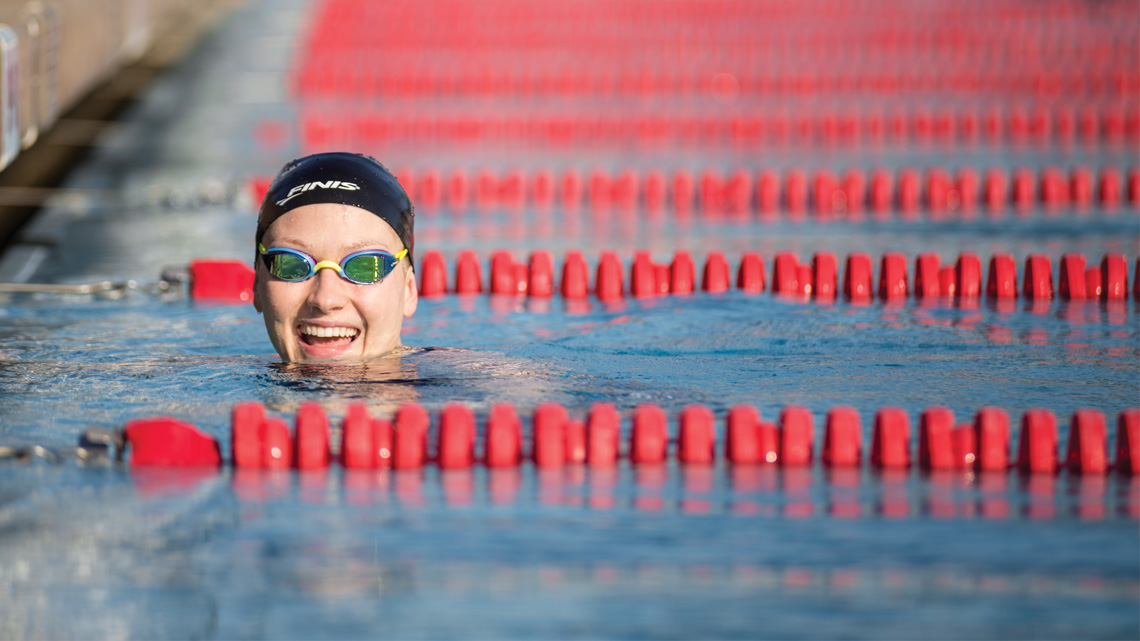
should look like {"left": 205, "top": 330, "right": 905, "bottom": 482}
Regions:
{"left": 124, "top": 403, "right": 1140, "bottom": 476}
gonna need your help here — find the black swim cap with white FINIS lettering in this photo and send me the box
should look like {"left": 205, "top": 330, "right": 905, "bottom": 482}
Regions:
{"left": 257, "top": 152, "right": 416, "bottom": 264}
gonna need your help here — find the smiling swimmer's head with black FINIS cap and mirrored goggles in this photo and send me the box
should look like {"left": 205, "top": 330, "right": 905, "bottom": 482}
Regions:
{"left": 253, "top": 152, "right": 418, "bottom": 363}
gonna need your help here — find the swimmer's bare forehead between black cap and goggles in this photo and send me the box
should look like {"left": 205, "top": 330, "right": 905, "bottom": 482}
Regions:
{"left": 262, "top": 203, "right": 404, "bottom": 251}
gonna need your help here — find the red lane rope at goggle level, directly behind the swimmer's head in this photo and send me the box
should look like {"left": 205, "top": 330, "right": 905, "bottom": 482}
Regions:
{"left": 190, "top": 250, "right": 1140, "bottom": 302}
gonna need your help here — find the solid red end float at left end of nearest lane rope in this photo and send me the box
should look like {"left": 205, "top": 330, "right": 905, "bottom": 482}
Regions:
{"left": 123, "top": 416, "right": 221, "bottom": 468}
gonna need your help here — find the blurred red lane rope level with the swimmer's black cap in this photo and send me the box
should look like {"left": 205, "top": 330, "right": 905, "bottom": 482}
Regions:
{"left": 249, "top": 165, "right": 1140, "bottom": 216}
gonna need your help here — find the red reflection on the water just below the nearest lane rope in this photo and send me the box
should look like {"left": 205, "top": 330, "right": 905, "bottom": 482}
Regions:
{"left": 156, "top": 464, "right": 1140, "bottom": 520}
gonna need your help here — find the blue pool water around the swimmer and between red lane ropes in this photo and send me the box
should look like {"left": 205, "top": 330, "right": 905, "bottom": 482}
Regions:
{"left": 0, "top": 2, "right": 1140, "bottom": 639}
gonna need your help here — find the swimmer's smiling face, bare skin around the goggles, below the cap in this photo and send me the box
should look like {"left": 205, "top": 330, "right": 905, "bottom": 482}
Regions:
{"left": 253, "top": 203, "right": 418, "bottom": 363}
